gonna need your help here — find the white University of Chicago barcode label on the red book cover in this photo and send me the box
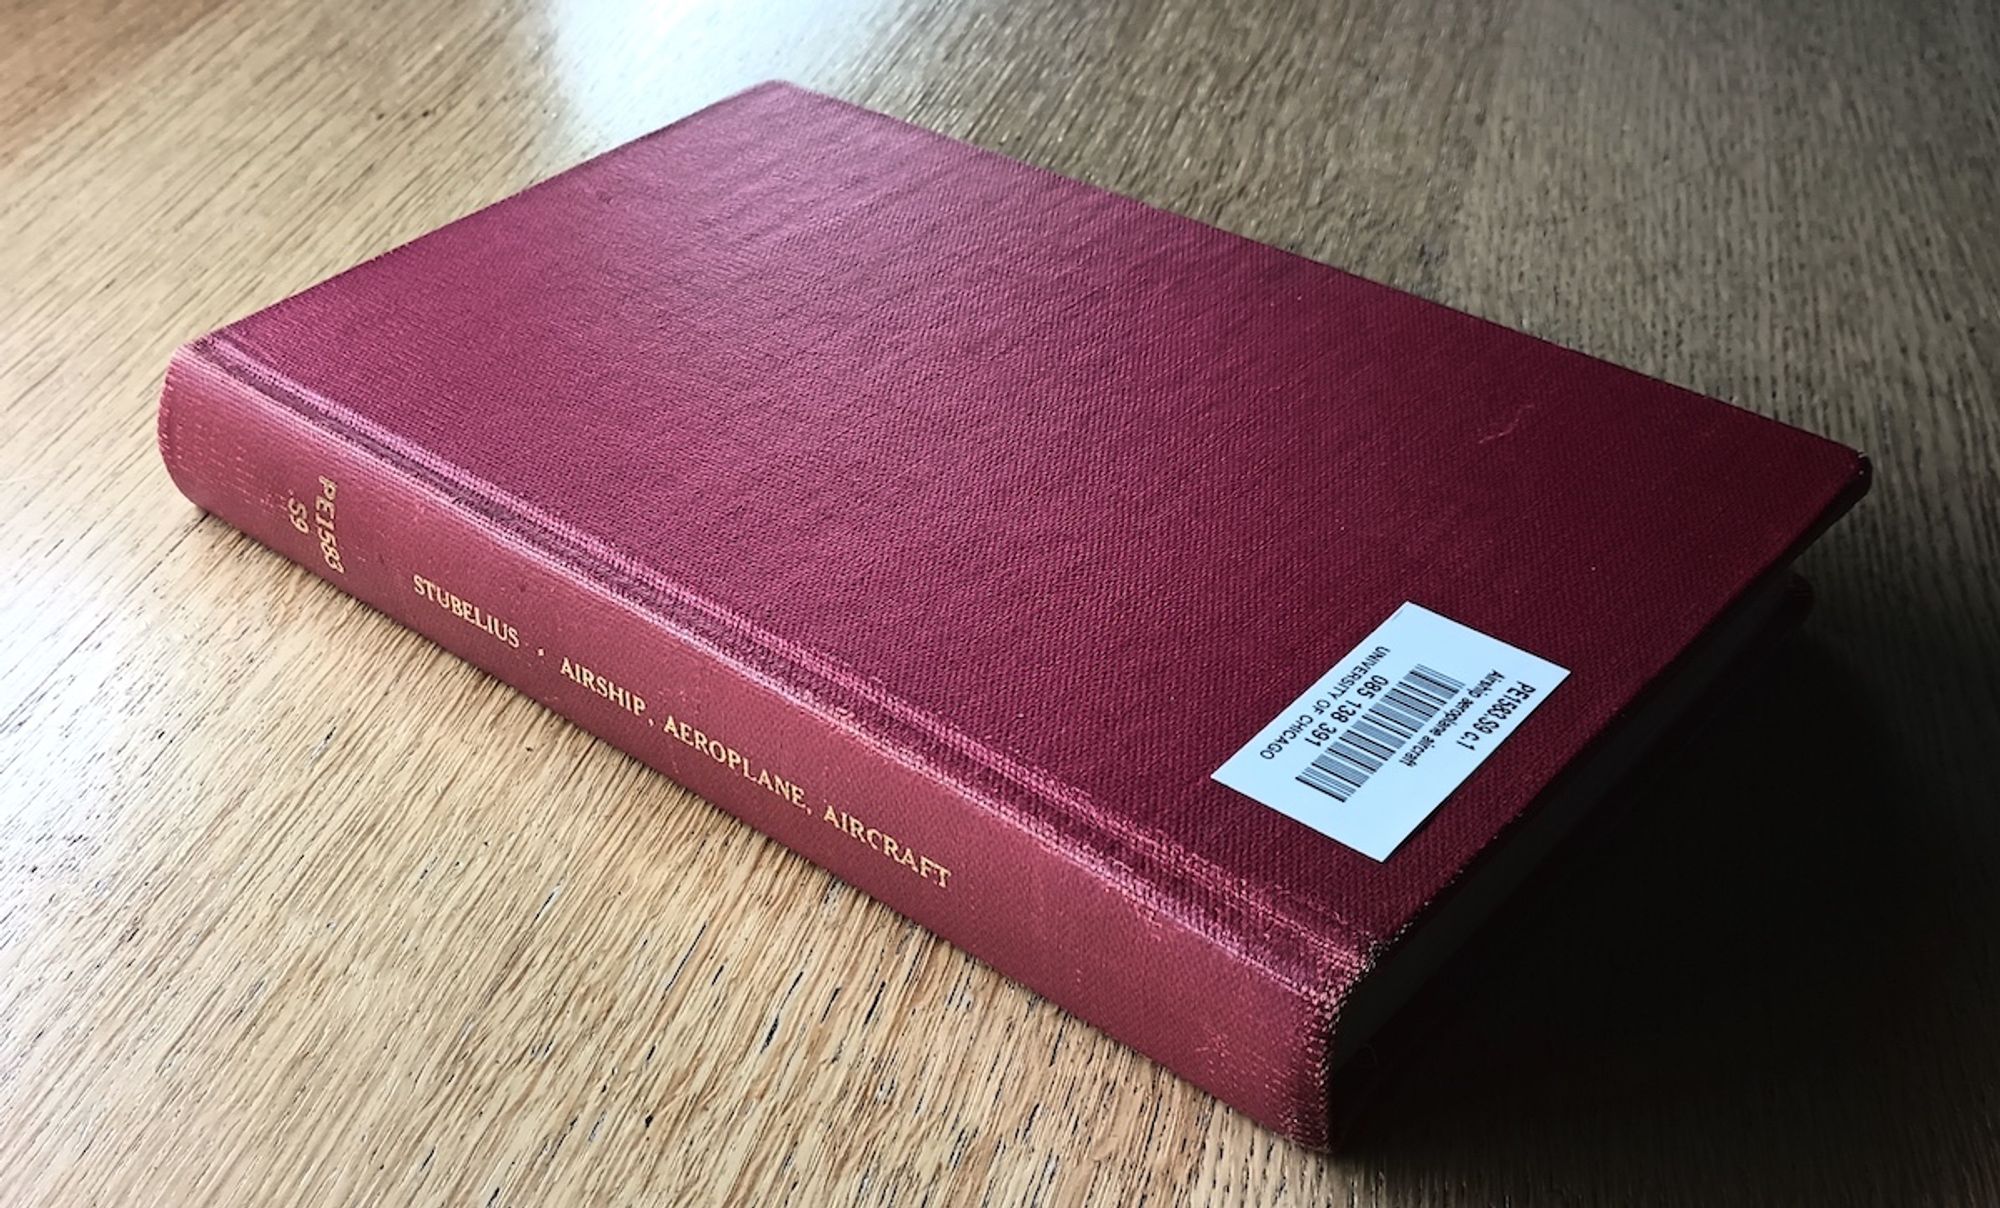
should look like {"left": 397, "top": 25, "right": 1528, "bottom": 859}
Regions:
{"left": 1216, "top": 604, "right": 1570, "bottom": 860}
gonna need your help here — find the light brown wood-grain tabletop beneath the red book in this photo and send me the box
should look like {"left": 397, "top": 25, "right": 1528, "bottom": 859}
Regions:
{"left": 0, "top": 0, "right": 2000, "bottom": 1206}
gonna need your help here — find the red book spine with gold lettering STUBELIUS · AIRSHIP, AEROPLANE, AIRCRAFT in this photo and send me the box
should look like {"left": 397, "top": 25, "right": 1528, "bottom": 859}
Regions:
{"left": 160, "top": 338, "right": 1330, "bottom": 1144}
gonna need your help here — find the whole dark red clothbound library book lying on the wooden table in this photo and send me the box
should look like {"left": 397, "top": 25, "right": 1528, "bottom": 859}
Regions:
{"left": 160, "top": 86, "right": 1866, "bottom": 1142}
